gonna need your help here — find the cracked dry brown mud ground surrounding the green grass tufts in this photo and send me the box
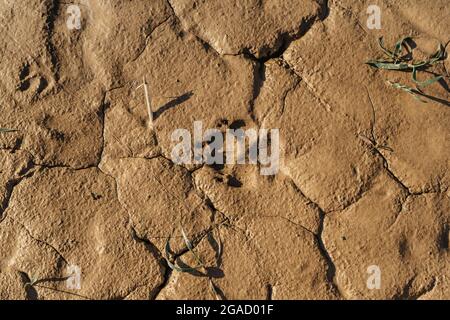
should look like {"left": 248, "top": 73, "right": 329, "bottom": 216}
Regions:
{"left": 0, "top": 0, "right": 450, "bottom": 299}
